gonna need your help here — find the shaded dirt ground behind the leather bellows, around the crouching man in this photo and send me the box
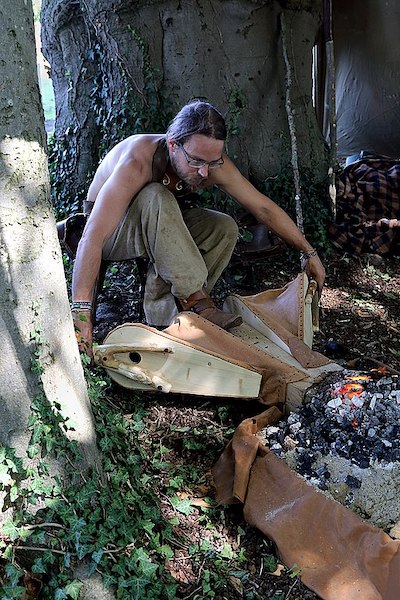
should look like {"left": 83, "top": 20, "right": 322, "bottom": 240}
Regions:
{"left": 97, "top": 248, "right": 400, "bottom": 370}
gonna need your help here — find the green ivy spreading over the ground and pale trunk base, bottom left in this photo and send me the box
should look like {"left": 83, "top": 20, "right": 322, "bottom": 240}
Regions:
{"left": 0, "top": 360, "right": 177, "bottom": 600}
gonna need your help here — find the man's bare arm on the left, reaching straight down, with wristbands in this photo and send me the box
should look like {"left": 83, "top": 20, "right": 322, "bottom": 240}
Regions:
{"left": 72, "top": 157, "right": 150, "bottom": 356}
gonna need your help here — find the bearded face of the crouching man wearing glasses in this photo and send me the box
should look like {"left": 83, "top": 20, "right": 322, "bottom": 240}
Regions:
{"left": 168, "top": 133, "right": 224, "bottom": 188}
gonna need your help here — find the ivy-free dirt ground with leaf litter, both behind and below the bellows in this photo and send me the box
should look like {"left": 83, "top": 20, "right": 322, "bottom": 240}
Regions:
{"left": 97, "top": 246, "right": 400, "bottom": 600}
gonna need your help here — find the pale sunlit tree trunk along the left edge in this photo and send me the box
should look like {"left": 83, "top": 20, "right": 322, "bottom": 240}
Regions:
{"left": 0, "top": 0, "right": 98, "bottom": 492}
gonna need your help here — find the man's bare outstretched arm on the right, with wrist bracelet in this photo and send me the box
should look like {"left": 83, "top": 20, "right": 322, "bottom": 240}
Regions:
{"left": 210, "top": 156, "right": 325, "bottom": 293}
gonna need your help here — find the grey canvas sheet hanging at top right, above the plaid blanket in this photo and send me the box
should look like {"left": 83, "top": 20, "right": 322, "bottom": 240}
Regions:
{"left": 332, "top": 0, "right": 400, "bottom": 159}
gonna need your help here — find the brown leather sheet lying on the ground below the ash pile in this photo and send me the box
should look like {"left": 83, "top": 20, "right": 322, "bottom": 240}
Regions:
{"left": 212, "top": 407, "right": 400, "bottom": 600}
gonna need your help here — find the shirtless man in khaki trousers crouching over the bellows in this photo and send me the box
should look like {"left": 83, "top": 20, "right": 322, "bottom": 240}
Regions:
{"left": 72, "top": 101, "right": 325, "bottom": 355}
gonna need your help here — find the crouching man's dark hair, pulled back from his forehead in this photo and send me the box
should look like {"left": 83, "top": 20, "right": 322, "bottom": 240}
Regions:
{"left": 166, "top": 100, "right": 226, "bottom": 144}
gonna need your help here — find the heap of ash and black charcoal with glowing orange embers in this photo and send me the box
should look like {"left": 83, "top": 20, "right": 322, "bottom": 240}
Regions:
{"left": 258, "top": 370, "right": 400, "bottom": 538}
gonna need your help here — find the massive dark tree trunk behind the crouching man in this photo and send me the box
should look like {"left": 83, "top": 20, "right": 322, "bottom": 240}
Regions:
{"left": 42, "top": 0, "right": 327, "bottom": 209}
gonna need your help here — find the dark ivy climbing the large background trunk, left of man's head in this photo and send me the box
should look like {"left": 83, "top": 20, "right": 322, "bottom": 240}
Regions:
{"left": 49, "top": 27, "right": 172, "bottom": 219}
